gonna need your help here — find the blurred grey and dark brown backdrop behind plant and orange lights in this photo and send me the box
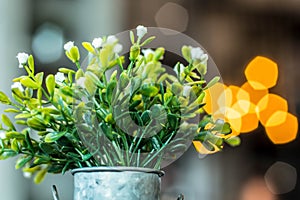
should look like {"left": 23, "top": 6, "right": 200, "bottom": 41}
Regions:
{"left": 0, "top": 0, "right": 300, "bottom": 200}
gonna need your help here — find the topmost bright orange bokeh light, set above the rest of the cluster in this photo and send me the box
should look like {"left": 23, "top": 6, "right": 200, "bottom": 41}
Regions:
{"left": 245, "top": 56, "right": 278, "bottom": 90}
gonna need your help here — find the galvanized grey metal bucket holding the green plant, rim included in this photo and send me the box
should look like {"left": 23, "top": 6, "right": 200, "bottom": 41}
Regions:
{"left": 72, "top": 167, "right": 164, "bottom": 200}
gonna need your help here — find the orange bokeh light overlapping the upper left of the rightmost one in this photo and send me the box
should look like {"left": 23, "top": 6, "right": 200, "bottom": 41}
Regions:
{"left": 256, "top": 94, "right": 288, "bottom": 126}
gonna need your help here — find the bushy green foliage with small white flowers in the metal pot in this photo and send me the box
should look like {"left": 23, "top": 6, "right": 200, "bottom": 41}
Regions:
{"left": 0, "top": 26, "right": 239, "bottom": 183}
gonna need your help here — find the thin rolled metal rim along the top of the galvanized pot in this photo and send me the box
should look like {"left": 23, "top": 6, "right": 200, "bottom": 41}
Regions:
{"left": 71, "top": 166, "right": 165, "bottom": 177}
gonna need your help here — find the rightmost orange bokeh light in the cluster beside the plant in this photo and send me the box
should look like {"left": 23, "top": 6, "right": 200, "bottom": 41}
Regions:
{"left": 265, "top": 113, "right": 298, "bottom": 144}
